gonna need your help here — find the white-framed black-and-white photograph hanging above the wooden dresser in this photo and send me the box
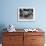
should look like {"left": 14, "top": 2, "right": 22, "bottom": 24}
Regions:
{"left": 18, "top": 7, "right": 35, "bottom": 21}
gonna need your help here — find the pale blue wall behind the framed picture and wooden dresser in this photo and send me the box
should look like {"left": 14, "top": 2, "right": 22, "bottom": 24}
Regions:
{"left": 0, "top": 0, "right": 46, "bottom": 29}
